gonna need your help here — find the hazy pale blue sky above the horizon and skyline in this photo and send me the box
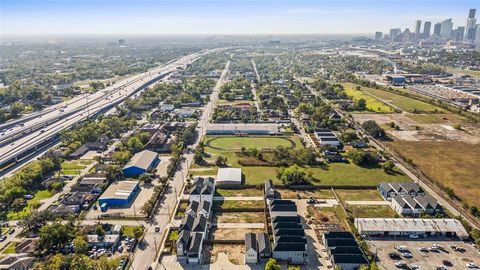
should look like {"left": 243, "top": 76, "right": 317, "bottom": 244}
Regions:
{"left": 0, "top": 0, "right": 480, "bottom": 35}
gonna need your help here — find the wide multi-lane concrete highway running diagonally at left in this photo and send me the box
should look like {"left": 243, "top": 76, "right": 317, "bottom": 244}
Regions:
{"left": 0, "top": 50, "right": 220, "bottom": 176}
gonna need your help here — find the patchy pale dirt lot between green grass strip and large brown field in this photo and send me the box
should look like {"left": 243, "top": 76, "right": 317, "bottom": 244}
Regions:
{"left": 353, "top": 113, "right": 480, "bottom": 144}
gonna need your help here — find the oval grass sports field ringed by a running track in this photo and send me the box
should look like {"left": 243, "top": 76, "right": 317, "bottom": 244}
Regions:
{"left": 205, "top": 136, "right": 302, "bottom": 150}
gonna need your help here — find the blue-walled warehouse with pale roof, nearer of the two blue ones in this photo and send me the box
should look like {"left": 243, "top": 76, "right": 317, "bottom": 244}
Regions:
{"left": 98, "top": 181, "right": 140, "bottom": 210}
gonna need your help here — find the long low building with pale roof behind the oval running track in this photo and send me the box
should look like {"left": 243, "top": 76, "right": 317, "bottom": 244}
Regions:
{"left": 206, "top": 123, "right": 280, "bottom": 135}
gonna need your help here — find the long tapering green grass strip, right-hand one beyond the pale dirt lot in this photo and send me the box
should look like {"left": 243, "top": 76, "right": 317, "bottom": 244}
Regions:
{"left": 344, "top": 83, "right": 445, "bottom": 113}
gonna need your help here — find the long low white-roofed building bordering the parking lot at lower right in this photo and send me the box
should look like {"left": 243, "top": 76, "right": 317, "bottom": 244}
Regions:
{"left": 355, "top": 218, "right": 469, "bottom": 240}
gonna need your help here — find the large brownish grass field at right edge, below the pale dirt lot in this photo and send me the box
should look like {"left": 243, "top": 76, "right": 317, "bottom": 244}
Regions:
{"left": 390, "top": 141, "right": 480, "bottom": 206}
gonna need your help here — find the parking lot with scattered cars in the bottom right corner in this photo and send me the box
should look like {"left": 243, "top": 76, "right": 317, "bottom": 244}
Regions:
{"left": 369, "top": 239, "right": 480, "bottom": 270}
